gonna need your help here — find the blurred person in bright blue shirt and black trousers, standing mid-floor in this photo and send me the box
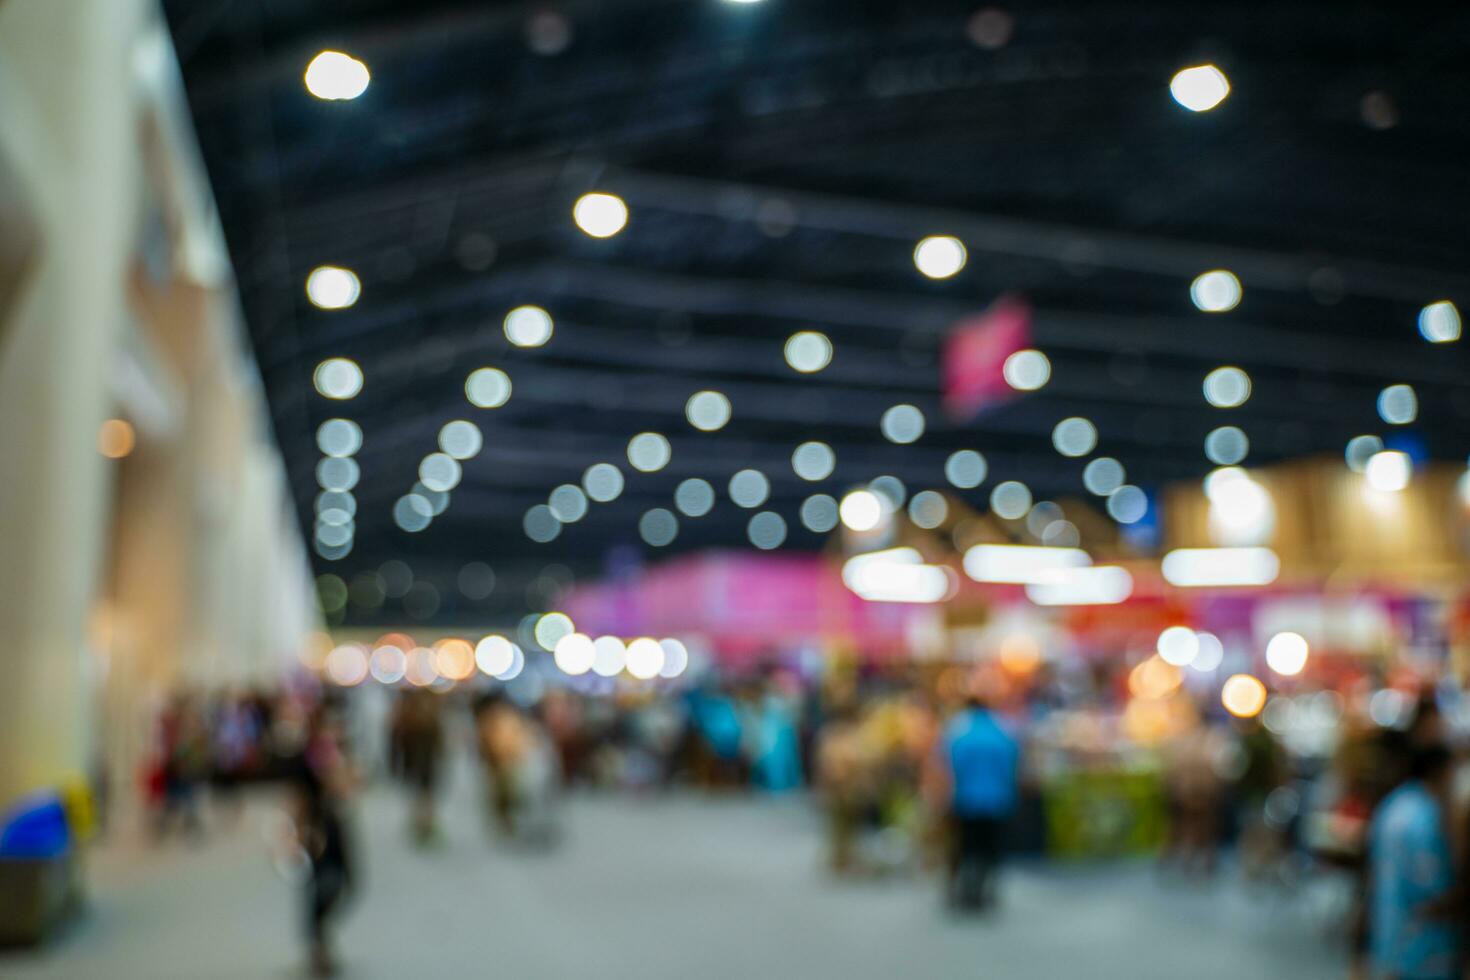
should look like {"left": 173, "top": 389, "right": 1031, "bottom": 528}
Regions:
{"left": 944, "top": 699, "right": 1020, "bottom": 908}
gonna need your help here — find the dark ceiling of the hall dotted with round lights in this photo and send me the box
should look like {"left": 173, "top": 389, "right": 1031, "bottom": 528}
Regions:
{"left": 166, "top": 0, "right": 1470, "bottom": 623}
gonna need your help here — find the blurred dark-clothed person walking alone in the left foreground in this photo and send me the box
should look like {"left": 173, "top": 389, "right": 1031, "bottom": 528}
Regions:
{"left": 291, "top": 708, "right": 356, "bottom": 977}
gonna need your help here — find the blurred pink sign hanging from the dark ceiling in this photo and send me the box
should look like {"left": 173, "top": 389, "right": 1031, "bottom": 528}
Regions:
{"left": 944, "top": 297, "right": 1030, "bottom": 420}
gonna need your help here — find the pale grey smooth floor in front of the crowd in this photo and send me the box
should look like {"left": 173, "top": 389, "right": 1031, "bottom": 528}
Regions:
{"left": 0, "top": 779, "right": 1345, "bottom": 980}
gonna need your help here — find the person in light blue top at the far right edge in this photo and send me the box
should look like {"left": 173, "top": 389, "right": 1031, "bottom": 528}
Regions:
{"left": 1369, "top": 745, "right": 1460, "bottom": 980}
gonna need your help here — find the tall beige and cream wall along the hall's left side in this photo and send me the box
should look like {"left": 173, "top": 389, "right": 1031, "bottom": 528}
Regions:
{"left": 0, "top": 0, "right": 319, "bottom": 807}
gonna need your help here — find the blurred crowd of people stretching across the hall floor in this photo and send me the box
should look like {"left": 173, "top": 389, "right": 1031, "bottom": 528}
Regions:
{"left": 146, "top": 664, "right": 1470, "bottom": 977}
